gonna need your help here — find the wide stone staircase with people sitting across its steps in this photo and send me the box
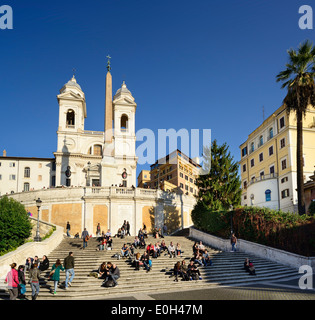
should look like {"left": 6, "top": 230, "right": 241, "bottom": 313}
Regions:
{"left": 0, "top": 236, "right": 297, "bottom": 300}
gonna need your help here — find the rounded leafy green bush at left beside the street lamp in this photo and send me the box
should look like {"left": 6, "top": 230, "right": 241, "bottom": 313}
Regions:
{"left": 0, "top": 196, "right": 32, "bottom": 253}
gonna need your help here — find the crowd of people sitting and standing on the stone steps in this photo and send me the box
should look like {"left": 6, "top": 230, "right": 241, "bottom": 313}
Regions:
{"left": 5, "top": 220, "right": 256, "bottom": 300}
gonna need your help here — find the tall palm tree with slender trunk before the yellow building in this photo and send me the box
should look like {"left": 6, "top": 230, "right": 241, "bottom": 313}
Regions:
{"left": 276, "top": 40, "right": 315, "bottom": 215}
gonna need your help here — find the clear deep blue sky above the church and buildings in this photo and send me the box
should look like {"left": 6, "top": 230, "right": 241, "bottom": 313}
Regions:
{"left": 0, "top": 0, "right": 315, "bottom": 178}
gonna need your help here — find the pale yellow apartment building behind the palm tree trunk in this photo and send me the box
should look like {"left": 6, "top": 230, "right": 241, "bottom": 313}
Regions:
{"left": 239, "top": 105, "right": 315, "bottom": 212}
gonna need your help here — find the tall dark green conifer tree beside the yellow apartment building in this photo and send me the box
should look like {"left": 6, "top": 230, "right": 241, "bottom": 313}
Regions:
{"left": 196, "top": 140, "right": 241, "bottom": 211}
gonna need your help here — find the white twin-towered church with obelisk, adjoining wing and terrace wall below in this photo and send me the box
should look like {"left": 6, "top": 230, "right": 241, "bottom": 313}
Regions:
{"left": 0, "top": 63, "right": 195, "bottom": 235}
